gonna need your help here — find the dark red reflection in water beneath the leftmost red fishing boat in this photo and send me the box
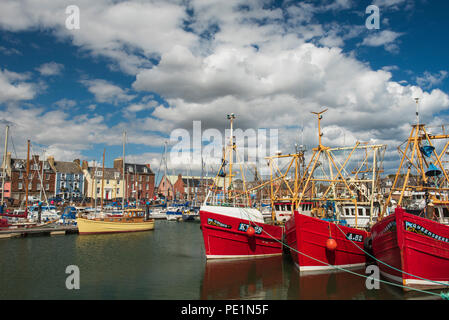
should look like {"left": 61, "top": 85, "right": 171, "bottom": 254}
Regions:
{"left": 201, "top": 256, "right": 286, "bottom": 300}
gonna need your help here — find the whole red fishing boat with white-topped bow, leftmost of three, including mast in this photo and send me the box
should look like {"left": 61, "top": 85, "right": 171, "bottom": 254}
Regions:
{"left": 200, "top": 114, "right": 283, "bottom": 259}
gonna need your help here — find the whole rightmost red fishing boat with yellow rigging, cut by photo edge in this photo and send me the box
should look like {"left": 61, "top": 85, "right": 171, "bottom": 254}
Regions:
{"left": 372, "top": 115, "right": 449, "bottom": 290}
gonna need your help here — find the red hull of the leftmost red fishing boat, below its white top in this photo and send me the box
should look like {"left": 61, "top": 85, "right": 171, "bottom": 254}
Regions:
{"left": 200, "top": 211, "right": 283, "bottom": 259}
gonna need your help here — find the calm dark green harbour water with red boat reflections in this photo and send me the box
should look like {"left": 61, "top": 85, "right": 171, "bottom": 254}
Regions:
{"left": 0, "top": 220, "right": 440, "bottom": 300}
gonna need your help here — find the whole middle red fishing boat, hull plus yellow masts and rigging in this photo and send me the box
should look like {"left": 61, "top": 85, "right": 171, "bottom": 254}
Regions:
{"left": 285, "top": 110, "right": 385, "bottom": 272}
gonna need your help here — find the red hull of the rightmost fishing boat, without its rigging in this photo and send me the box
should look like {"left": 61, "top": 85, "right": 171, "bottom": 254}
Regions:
{"left": 372, "top": 208, "right": 449, "bottom": 289}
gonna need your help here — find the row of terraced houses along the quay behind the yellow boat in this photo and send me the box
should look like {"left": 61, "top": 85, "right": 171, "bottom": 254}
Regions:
{"left": 0, "top": 152, "right": 154, "bottom": 204}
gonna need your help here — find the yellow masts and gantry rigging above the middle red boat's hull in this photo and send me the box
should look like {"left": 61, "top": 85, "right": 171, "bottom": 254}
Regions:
{"left": 293, "top": 109, "right": 386, "bottom": 227}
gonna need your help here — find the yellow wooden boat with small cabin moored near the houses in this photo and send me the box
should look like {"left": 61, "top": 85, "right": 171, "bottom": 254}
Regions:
{"left": 76, "top": 209, "right": 154, "bottom": 234}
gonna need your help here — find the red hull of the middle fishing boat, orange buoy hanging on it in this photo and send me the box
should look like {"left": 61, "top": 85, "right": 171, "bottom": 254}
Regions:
{"left": 285, "top": 211, "right": 369, "bottom": 271}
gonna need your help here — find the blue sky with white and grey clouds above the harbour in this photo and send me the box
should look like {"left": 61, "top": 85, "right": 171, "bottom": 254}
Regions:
{"left": 0, "top": 0, "right": 449, "bottom": 175}
